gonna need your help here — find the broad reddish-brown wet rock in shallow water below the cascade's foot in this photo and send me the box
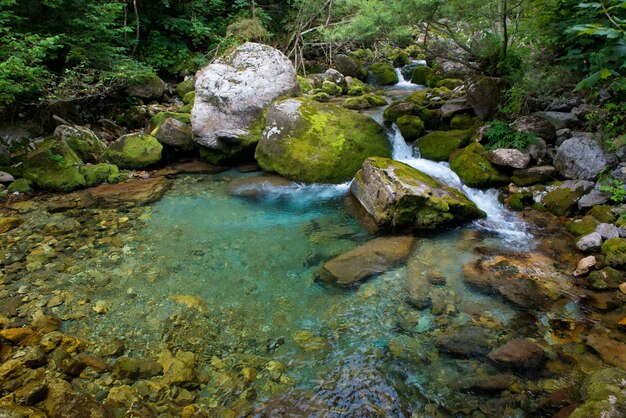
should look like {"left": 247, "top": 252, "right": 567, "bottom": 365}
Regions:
{"left": 463, "top": 253, "right": 571, "bottom": 310}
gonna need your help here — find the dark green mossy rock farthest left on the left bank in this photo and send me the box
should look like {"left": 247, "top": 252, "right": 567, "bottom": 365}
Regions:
{"left": 24, "top": 139, "right": 86, "bottom": 192}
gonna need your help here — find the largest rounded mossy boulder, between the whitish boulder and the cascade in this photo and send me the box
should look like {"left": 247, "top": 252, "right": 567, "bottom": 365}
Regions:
{"left": 255, "top": 98, "right": 391, "bottom": 183}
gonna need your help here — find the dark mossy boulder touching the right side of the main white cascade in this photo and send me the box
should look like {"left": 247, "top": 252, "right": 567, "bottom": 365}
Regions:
{"left": 450, "top": 143, "right": 509, "bottom": 189}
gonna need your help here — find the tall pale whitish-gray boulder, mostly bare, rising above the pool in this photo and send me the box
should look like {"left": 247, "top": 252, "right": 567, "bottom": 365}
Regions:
{"left": 191, "top": 42, "right": 300, "bottom": 164}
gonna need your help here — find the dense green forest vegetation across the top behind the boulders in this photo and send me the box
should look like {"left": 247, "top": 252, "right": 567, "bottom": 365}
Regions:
{"left": 0, "top": 0, "right": 626, "bottom": 112}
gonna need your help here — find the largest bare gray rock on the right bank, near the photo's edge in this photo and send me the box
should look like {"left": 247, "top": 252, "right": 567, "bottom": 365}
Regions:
{"left": 554, "top": 133, "right": 617, "bottom": 180}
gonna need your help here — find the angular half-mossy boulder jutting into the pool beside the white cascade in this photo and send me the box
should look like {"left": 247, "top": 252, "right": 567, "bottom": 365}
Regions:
{"left": 350, "top": 158, "right": 485, "bottom": 229}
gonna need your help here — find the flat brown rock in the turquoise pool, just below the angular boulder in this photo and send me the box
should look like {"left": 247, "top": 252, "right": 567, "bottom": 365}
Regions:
{"left": 320, "top": 236, "right": 415, "bottom": 286}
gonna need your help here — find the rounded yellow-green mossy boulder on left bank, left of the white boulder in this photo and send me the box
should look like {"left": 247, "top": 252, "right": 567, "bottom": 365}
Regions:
{"left": 102, "top": 133, "right": 163, "bottom": 170}
